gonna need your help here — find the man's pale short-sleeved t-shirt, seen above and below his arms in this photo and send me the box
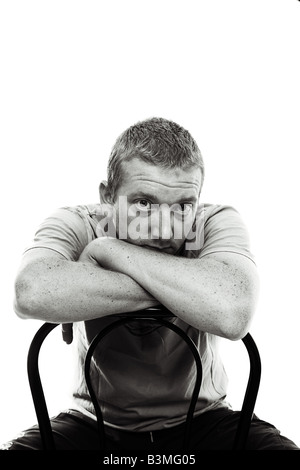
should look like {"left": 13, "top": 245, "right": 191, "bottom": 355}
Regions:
{"left": 27, "top": 204, "right": 253, "bottom": 431}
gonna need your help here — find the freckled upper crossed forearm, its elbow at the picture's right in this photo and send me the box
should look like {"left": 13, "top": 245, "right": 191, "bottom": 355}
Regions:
{"left": 97, "top": 241, "right": 256, "bottom": 339}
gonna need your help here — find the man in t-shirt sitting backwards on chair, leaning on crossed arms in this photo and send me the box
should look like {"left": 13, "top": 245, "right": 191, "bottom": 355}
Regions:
{"left": 1, "top": 118, "right": 297, "bottom": 452}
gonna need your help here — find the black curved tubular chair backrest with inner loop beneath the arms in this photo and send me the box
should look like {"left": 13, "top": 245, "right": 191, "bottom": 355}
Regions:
{"left": 27, "top": 309, "right": 261, "bottom": 450}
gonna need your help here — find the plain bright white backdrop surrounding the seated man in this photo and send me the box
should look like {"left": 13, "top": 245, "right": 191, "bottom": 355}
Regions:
{"left": 0, "top": 0, "right": 300, "bottom": 445}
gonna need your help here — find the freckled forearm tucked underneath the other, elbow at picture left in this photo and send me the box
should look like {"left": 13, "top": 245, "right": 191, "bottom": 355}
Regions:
{"left": 15, "top": 253, "right": 157, "bottom": 323}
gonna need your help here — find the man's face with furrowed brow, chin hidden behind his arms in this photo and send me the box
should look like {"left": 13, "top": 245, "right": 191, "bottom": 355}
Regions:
{"left": 114, "top": 158, "right": 202, "bottom": 254}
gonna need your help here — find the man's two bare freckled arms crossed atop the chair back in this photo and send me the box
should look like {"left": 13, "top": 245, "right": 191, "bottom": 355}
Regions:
{"left": 14, "top": 237, "right": 259, "bottom": 340}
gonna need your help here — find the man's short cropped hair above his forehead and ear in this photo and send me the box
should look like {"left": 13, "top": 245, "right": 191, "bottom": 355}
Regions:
{"left": 107, "top": 117, "right": 204, "bottom": 199}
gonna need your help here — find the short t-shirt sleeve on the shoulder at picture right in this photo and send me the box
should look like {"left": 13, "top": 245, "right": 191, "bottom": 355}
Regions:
{"left": 186, "top": 204, "right": 255, "bottom": 262}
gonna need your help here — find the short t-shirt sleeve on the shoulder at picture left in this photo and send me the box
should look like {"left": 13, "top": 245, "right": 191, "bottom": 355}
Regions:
{"left": 25, "top": 208, "right": 91, "bottom": 261}
